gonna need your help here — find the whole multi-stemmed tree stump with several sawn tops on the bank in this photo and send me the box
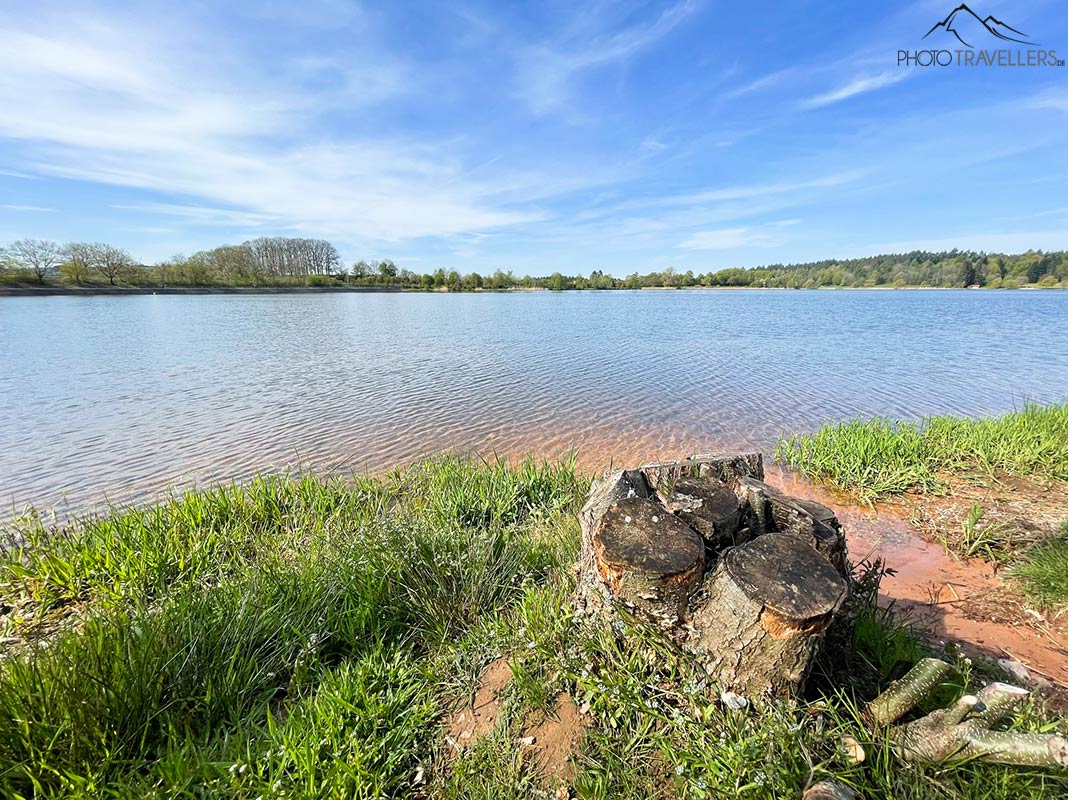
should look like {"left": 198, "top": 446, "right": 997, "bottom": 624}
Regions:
{"left": 576, "top": 453, "right": 848, "bottom": 695}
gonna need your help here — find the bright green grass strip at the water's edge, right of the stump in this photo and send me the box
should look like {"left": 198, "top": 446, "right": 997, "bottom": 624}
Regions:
{"left": 775, "top": 403, "right": 1068, "bottom": 502}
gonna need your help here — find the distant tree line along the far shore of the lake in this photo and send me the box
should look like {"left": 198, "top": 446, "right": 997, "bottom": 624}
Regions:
{"left": 0, "top": 236, "right": 1068, "bottom": 292}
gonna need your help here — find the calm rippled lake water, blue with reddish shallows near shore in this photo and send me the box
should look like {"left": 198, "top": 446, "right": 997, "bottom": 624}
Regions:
{"left": 0, "top": 291, "right": 1068, "bottom": 513}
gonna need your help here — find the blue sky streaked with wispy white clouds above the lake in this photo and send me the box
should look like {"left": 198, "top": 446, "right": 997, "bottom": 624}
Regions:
{"left": 0, "top": 0, "right": 1068, "bottom": 274}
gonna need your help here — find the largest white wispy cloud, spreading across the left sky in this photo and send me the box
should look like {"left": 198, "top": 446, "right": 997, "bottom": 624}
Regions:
{"left": 0, "top": 7, "right": 551, "bottom": 241}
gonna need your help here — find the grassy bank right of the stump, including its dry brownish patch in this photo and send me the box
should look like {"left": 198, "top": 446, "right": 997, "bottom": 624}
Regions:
{"left": 775, "top": 403, "right": 1068, "bottom": 611}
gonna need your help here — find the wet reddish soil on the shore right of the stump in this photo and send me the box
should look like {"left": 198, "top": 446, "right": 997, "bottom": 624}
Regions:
{"left": 766, "top": 466, "right": 1068, "bottom": 687}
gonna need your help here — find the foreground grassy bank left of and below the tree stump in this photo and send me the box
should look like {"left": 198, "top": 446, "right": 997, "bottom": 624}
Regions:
{"left": 0, "top": 457, "right": 1068, "bottom": 800}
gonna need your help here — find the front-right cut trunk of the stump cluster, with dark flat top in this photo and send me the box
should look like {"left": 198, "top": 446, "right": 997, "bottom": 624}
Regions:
{"left": 687, "top": 534, "right": 847, "bottom": 695}
